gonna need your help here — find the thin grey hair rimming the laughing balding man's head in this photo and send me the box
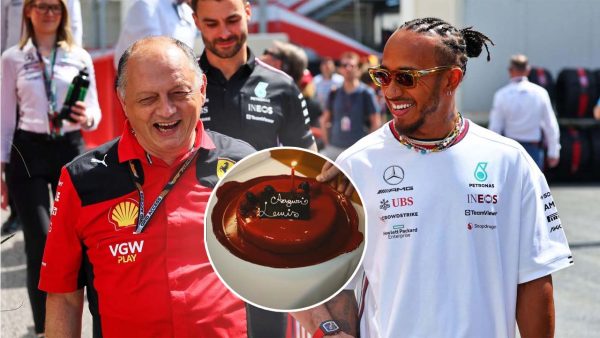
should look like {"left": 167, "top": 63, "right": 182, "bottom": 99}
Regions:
{"left": 115, "top": 36, "right": 202, "bottom": 97}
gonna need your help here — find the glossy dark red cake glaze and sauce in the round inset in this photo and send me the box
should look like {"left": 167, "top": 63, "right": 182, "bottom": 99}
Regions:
{"left": 211, "top": 175, "right": 363, "bottom": 267}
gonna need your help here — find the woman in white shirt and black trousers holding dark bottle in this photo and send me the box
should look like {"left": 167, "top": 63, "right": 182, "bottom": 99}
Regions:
{"left": 1, "top": 0, "right": 101, "bottom": 335}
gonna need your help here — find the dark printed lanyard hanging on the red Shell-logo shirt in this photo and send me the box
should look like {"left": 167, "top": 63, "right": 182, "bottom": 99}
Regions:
{"left": 129, "top": 150, "right": 198, "bottom": 234}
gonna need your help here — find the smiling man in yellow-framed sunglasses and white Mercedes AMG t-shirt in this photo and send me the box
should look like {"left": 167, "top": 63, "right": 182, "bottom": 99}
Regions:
{"left": 293, "top": 18, "right": 573, "bottom": 338}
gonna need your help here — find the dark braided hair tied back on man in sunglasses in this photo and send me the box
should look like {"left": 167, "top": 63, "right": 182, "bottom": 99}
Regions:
{"left": 398, "top": 18, "right": 494, "bottom": 74}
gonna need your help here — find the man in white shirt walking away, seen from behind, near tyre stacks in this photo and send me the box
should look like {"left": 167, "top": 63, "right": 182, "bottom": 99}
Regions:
{"left": 488, "top": 54, "right": 560, "bottom": 169}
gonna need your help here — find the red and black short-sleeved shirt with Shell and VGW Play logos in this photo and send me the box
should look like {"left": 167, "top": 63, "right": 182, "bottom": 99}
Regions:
{"left": 40, "top": 123, "right": 252, "bottom": 337}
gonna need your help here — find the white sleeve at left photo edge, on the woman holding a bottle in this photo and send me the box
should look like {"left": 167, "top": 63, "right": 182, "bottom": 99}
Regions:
{"left": 0, "top": 53, "right": 17, "bottom": 163}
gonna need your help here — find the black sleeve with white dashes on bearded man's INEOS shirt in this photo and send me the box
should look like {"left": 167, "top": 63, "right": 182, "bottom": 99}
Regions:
{"left": 279, "top": 84, "right": 315, "bottom": 148}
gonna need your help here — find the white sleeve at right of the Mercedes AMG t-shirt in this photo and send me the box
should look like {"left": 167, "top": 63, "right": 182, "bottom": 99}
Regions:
{"left": 518, "top": 154, "right": 573, "bottom": 284}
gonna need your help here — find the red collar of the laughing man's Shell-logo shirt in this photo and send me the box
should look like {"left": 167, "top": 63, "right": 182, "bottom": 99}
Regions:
{"left": 118, "top": 120, "right": 215, "bottom": 164}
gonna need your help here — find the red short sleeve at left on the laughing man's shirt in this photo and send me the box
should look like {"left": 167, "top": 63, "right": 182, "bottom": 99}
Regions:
{"left": 39, "top": 167, "right": 82, "bottom": 293}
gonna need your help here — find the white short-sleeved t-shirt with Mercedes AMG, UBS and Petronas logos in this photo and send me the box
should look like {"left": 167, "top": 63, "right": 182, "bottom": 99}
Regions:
{"left": 337, "top": 121, "right": 573, "bottom": 338}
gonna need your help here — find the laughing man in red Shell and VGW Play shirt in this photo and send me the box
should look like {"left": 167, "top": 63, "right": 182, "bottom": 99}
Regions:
{"left": 40, "top": 37, "right": 253, "bottom": 337}
